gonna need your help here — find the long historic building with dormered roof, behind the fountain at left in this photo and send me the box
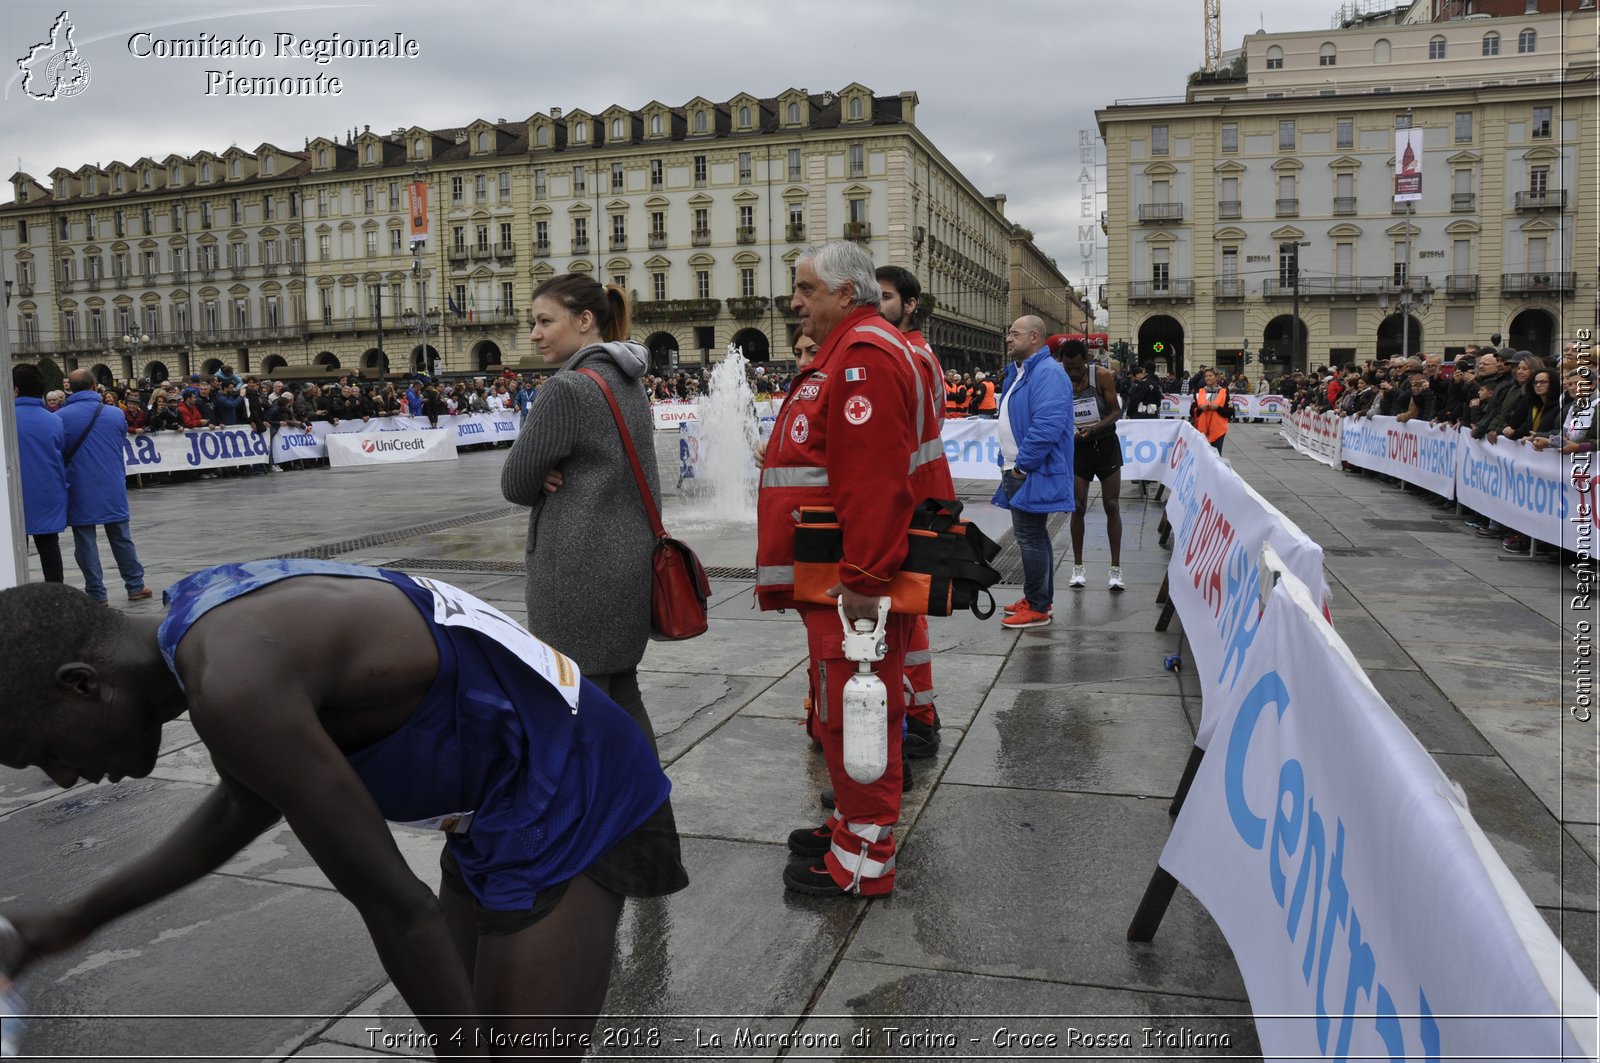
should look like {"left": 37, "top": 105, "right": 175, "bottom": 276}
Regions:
{"left": 0, "top": 85, "right": 1067, "bottom": 379}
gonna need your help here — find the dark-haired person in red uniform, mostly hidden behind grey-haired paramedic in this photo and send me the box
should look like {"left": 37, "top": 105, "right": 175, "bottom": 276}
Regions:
{"left": 877, "top": 266, "right": 955, "bottom": 759}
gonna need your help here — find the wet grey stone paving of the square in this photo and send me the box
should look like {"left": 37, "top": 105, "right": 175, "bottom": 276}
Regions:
{"left": 0, "top": 424, "right": 1600, "bottom": 1060}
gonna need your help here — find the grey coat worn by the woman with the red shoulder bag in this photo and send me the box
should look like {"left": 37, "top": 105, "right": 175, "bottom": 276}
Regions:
{"left": 501, "top": 341, "right": 661, "bottom": 674}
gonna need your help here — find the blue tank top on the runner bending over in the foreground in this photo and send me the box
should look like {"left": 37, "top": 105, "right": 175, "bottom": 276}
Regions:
{"left": 158, "top": 560, "right": 672, "bottom": 911}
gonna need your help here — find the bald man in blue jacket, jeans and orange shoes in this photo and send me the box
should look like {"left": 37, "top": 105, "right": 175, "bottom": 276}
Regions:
{"left": 994, "top": 314, "right": 1075, "bottom": 628}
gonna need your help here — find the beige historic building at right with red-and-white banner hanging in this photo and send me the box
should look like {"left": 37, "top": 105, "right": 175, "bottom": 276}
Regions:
{"left": 1098, "top": 0, "right": 1600, "bottom": 373}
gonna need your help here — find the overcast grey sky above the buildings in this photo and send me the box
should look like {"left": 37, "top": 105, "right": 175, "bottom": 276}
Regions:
{"left": 0, "top": 0, "right": 1336, "bottom": 302}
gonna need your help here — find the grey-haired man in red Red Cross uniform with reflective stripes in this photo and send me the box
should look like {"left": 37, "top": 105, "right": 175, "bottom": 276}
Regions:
{"left": 755, "top": 242, "right": 942, "bottom": 897}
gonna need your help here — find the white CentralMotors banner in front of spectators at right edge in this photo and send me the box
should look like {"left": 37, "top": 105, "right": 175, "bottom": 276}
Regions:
{"left": 1456, "top": 429, "right": 1595, "bottom": 551}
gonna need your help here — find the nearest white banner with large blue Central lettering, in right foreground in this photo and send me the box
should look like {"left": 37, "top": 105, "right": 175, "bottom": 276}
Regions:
{"left": 1160, "top": 560, "right": 1597, "bottom": 1060}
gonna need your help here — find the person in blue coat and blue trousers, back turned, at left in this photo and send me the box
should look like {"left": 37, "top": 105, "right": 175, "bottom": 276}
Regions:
{"left": 58, "top": 370, "right": 150, "bottom": 605}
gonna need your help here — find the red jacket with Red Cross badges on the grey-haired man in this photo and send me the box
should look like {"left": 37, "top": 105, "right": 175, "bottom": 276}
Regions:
{"left": 755, "top": 306, "right": 936, "bottom": 608}
